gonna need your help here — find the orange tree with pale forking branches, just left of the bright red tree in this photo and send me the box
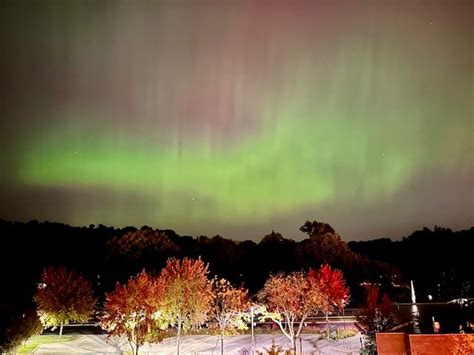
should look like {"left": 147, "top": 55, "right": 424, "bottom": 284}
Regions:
{"left": 259, "top": 272, "right": 323, "bottom": 352}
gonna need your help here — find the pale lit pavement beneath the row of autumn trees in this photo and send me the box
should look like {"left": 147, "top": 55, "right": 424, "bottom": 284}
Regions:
{"left": 35, "top": 334, "right": 360, "bottom": 355}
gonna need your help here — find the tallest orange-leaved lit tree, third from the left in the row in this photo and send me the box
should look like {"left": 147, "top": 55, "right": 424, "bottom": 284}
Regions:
{"left": 161, "top": 258, "right": 212, "bottom": 354}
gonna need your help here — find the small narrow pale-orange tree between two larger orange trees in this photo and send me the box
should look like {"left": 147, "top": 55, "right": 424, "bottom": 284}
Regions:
{"left": 211, "top": 278, "right": 250, "bottom": 354}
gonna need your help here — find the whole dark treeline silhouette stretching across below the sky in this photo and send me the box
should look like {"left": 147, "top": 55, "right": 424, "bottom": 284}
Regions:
{"left": 0, "top": 220, "right": 474, "bottom": 314}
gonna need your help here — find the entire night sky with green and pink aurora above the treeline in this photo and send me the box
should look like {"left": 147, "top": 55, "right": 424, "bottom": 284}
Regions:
{"left": 0, "top": 0, "right": 474, "bottom": 240}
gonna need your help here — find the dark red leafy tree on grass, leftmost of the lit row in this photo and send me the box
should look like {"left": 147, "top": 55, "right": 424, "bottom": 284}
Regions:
{"left": 33, "top": 267, "right": 96, "bottom": 336}
